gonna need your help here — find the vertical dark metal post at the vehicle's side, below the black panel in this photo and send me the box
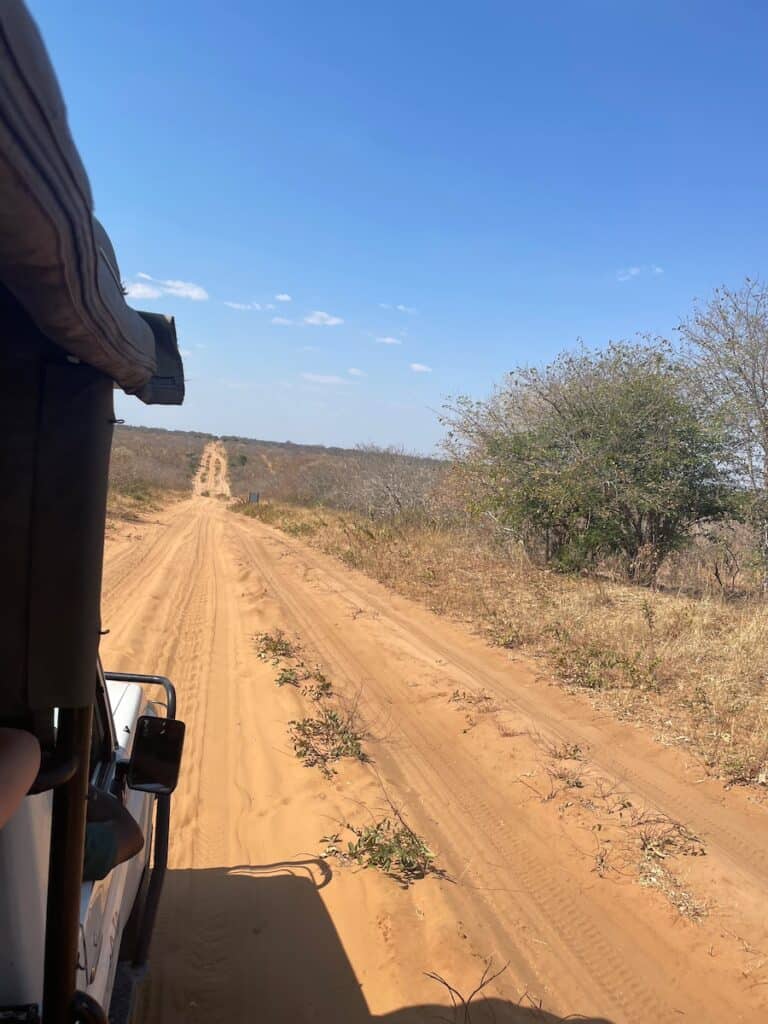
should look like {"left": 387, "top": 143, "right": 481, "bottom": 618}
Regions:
{"left": 43, "top": 705, "right": 93, "bottom": 1024}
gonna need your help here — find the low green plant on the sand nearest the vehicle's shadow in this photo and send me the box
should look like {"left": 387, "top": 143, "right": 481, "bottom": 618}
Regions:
{"left": 324, "top": 815, "right": 435, "bottom": 886}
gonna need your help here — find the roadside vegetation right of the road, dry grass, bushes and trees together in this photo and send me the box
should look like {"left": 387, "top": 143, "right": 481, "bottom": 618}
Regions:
{"left": 233, "top": 281, "right": 768, "bottom": 785}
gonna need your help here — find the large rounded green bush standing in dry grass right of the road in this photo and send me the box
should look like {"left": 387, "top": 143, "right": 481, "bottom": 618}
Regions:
{"left": 446, "top": 344, "right": 731, "bottom": 583}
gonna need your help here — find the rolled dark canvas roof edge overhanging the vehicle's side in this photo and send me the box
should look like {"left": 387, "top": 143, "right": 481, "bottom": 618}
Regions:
{"left": 0, "top": 0, "right": 183, "bottom": 404}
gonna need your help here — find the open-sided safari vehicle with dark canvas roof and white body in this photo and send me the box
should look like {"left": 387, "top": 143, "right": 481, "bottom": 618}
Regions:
{"left": 0, "top": 0, "right": 184, "bottom": 1024}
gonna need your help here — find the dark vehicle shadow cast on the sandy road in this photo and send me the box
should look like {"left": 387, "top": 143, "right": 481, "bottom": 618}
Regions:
{"left": 140, "top": 859, "right": 611, "bottom": 1024}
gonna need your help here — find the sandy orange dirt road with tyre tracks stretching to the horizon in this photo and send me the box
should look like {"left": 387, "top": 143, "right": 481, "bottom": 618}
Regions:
{"left": 103, "top": 450, "right": 768, "bottom": 1024}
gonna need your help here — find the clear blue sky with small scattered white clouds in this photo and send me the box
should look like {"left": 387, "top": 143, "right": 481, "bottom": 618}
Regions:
{"left": 30, "top": 0, "right": 768, "bottom": 451}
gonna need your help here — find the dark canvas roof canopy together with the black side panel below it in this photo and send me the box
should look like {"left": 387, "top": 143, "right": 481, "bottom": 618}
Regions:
{"left": 0, "top": 0, "right": 184, "bottom": 723}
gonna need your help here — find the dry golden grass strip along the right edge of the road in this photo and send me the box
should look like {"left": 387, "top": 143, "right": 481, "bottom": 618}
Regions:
{"left": 242, "top": 504, "right": 768, "bottom": 784}
